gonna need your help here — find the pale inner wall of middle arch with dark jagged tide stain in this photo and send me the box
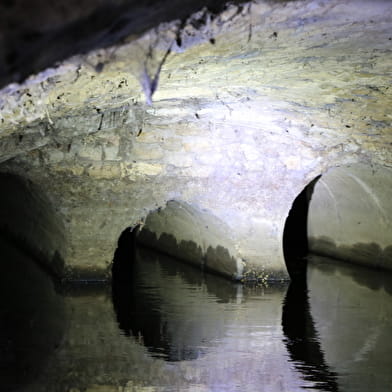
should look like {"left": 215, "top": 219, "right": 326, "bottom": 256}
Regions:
{"left": 137, "top": 200, "right": 243, "bottom": 279}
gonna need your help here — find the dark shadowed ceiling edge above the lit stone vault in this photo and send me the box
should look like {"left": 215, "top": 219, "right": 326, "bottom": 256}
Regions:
{"left": 0, "top": 0, "right": 250, "bottom": 88}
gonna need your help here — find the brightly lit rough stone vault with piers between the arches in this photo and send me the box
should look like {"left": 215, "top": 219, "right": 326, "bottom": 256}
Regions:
{"left": 0, "top": 0, "right": 392, "bottom": 282}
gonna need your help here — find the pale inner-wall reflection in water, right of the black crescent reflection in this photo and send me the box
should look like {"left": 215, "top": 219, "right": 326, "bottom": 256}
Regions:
{"left": 308, "top": 256, "right": 392, "bottom": 392}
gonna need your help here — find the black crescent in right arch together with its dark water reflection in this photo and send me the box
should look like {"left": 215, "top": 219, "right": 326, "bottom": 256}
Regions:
{"left": 282, "top": 176, "right": 339, "bottom": 392}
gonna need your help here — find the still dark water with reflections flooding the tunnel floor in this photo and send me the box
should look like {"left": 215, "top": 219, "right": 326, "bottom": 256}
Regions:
{"left": 0, "top": 237, "right": 392, "bottom": 392}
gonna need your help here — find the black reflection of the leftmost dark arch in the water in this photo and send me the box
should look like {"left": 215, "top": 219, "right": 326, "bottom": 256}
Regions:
{"left": 0, "top": 237, "right": 65, "bottom": 391}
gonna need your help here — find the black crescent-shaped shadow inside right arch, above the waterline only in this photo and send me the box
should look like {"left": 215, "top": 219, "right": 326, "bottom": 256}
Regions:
{"left": 283, "top": 176, "right": 321, "bottom": 280}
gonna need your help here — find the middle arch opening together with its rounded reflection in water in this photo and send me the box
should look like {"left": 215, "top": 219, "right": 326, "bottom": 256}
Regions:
{"left": 108, "top": 201, "right": 242, "bottom": 362}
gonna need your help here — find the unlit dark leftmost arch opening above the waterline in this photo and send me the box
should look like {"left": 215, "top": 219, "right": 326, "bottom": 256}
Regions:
{"left": 0, "top": 173, "right": 66, "bottom": 278}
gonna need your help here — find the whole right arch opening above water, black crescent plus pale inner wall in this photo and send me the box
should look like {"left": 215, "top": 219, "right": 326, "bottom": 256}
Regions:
{"left": 283, "top": 163, "right": 392, "bottom": 275}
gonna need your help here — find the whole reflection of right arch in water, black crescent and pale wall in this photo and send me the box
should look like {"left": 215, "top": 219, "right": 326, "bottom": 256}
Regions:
{"left": 282, "top": 256, "right": 392, "bottom": 392}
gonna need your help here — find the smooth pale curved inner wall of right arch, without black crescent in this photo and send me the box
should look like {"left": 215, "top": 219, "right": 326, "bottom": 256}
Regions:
{"left": 308, "top": 164, "right": 392, "bottom": 269}
